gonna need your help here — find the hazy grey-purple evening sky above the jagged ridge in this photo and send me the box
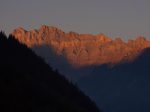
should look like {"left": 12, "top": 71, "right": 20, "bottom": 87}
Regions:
{"left": 0, "top": 0, "right": 150, "bottom": 39}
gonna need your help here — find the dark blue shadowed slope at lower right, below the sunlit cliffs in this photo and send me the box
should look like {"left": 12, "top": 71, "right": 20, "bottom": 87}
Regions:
{"left": 77, "top": 48, "right": 150, "bottom": 112}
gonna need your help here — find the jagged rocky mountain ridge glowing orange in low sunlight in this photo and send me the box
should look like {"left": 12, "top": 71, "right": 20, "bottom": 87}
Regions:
{"left": 12, "top": 25, "right": 150, "bottom": 67}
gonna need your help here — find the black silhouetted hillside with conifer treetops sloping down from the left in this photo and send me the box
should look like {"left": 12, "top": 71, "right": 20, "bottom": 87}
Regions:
{"left": 0, "top": 32, "right": 99, "bottom": 112}
